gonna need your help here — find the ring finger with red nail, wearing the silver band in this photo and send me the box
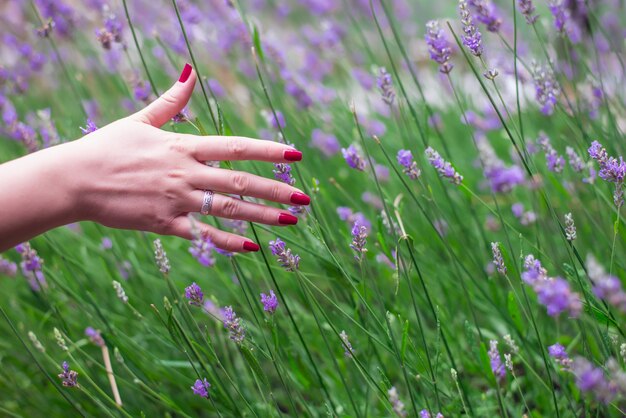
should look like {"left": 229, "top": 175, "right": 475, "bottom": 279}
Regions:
{"left": 183, "top": 190, "right": 298, "bottom": 226}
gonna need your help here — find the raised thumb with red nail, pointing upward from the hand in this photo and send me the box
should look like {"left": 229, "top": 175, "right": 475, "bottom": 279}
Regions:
{"left": 133, "top": 64, "right": 196, "bottom": 128}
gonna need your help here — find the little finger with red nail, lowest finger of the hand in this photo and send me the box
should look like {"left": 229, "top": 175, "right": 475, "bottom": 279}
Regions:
{"left": 169, "top": 216, "right": 259, "bottom": 252}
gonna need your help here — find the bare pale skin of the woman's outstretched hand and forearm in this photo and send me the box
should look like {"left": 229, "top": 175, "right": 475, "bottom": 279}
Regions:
{"left": 0, "top": 66, "right": 309, "bottom": 252}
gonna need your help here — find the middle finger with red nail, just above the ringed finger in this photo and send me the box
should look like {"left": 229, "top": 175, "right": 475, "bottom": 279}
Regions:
{"left": 190, "top": 164, "right": 311, "bottom": 205}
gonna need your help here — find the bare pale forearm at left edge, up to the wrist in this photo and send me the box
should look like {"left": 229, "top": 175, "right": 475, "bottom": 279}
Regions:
{"left": 0, "top": 144, "right": 80, "bottom": 252}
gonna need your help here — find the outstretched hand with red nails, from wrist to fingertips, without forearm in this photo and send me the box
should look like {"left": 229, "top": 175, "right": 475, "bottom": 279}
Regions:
{"left": 1, "top": 62, "right": 310, "bottom": 252}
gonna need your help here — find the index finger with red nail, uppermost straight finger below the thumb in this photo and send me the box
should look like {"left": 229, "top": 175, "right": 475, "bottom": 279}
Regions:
{"left": 182, "top": 135, "right": 302, "bottom": 163}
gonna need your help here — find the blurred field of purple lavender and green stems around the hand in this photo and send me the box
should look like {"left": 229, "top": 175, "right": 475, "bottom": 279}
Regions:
{"left": 0, "top": 0, "right": 626, "bottom": 418}
